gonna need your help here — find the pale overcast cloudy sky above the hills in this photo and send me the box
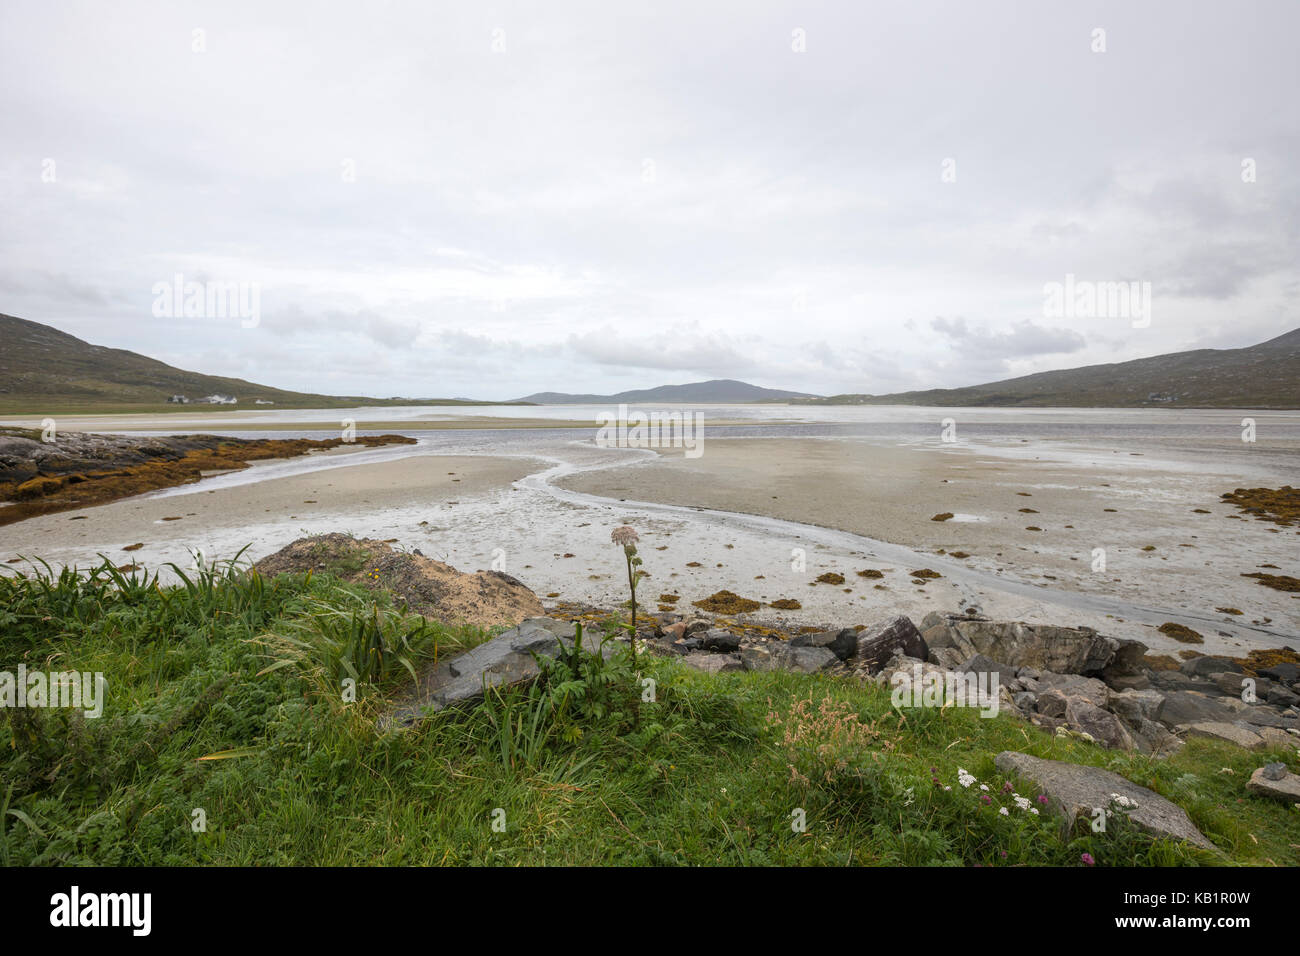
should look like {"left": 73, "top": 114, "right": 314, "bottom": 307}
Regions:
{"left": 0, "top": 0, "right": 1300, "bottom": 399}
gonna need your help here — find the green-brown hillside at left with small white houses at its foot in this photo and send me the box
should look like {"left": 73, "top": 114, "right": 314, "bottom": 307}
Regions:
{"left": 0, "top": 315, "right": 506, "bottom": 412}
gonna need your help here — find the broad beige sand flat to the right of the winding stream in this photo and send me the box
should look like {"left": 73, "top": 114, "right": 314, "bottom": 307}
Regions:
{"left": 559, "top": 438, "right": 1300, "bottom": 648}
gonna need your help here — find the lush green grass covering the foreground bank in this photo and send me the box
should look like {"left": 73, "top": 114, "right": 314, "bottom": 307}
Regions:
{"left": 0, "top": 562, "right": 1300, "bottom": 865}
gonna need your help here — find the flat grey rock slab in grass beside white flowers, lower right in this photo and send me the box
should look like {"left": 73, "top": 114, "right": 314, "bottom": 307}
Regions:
{"left": 995, "top": 750, "right": 1214, "bottom": 849}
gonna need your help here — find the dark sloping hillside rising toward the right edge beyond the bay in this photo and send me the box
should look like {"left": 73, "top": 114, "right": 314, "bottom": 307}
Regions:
{"left": 796, "top": 329, "right": 1300, "bottom": 408}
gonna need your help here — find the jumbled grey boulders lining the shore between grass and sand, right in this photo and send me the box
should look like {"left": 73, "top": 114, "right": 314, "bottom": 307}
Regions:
{"left": 649, "top": 613, "right": 1300, "bottom": 754}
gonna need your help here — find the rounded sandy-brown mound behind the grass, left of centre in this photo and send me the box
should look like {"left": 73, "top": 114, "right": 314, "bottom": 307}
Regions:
{"left": 257, "top": 533, "right": 545, "bottom": 627}
